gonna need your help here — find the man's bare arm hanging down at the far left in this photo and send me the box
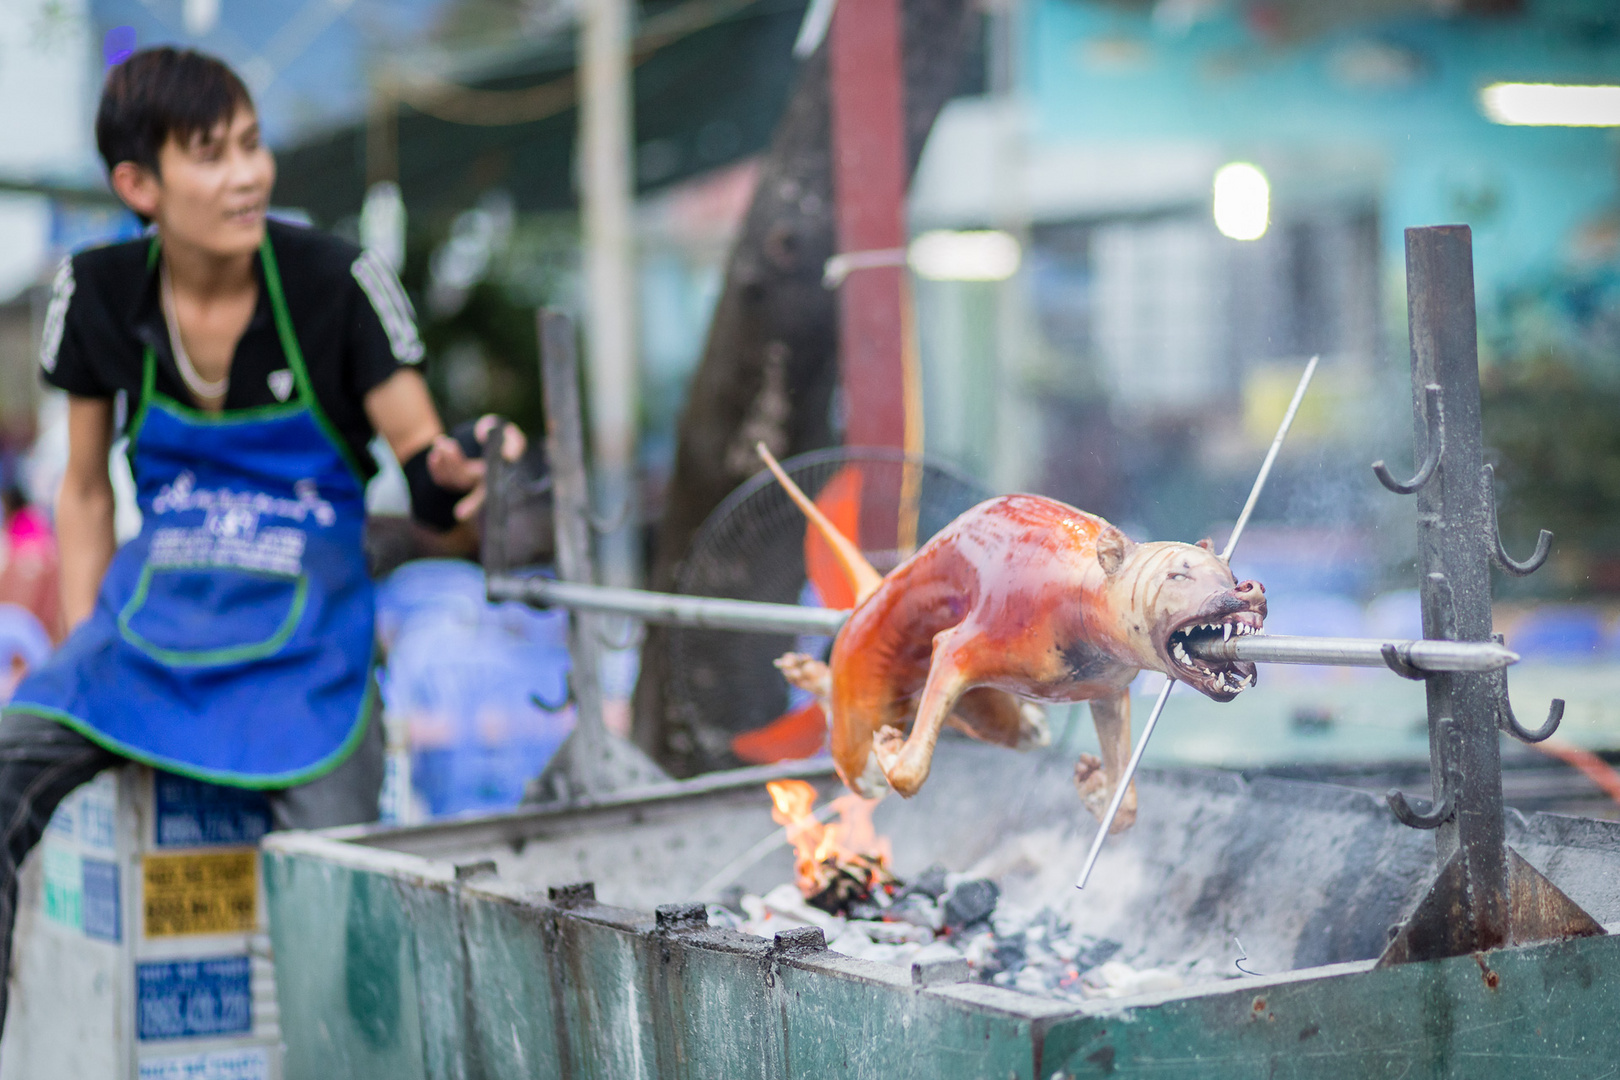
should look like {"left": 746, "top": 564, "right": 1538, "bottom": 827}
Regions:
{"left": 57, "top": 395, "right": 117, "bottom": 633}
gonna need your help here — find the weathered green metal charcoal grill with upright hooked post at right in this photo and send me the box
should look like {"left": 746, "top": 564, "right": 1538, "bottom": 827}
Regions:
{"left": 264, "top": 227, "right": 1620, "bottom": 1080}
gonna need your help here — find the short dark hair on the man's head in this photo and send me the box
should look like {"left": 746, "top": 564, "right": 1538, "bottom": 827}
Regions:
{"left": 96, "top": 45, "right": 253, "bottom": 173}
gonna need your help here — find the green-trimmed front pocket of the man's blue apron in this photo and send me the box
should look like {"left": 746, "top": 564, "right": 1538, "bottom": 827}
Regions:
{"left": 118, "top": 565, "right": 309, "bottom": 667}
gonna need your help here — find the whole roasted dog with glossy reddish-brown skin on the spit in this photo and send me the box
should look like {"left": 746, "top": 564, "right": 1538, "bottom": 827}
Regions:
{"left": 766, "top": 443, "right": 1265, "bottom": 831}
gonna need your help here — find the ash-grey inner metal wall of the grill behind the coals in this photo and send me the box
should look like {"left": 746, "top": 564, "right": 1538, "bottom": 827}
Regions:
{"left": 351, "top": 740, "right": 1620, "bottom": 972}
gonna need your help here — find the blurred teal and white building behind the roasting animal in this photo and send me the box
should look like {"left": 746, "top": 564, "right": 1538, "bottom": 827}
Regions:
{"left": 910, "top": 0, "right": 1620, "bottom": 589}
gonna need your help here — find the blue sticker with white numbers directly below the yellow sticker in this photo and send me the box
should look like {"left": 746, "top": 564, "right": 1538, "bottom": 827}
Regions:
{"left": 134, "top": 957, "right": 253, "bottom": 1041}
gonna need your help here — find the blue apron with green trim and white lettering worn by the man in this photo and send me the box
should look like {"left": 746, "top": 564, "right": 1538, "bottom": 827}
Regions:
{"left": 6, "top": 236, "right": 374, "bottom": 787}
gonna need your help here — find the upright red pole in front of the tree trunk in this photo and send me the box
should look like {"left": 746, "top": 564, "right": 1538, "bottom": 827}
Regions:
{"left": 828, "top": 0, "right": 910, "bottom": 449}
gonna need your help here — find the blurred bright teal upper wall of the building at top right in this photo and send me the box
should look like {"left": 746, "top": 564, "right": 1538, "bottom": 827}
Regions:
{"left": 1021, "top": 0, "right": 1620, "bottom": 309}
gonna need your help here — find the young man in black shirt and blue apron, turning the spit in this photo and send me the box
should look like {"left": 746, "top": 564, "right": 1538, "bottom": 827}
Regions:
{"left": 0, "top": 49, "right": 522, "bottom": 1017}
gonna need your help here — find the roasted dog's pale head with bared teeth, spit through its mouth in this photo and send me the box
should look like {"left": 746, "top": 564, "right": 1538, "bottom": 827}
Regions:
{"left": 1097, "top": 525, "right": 1265, "bottom": 701}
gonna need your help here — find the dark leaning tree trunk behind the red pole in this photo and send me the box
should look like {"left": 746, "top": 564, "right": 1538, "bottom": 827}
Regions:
{"left": 633, "top": 0, "right": 978, "bottom": 776}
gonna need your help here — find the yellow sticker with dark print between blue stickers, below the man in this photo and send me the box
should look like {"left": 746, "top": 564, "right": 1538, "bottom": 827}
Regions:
{"left": 141, "top": 848, "right": 259, "bottom": 938}
